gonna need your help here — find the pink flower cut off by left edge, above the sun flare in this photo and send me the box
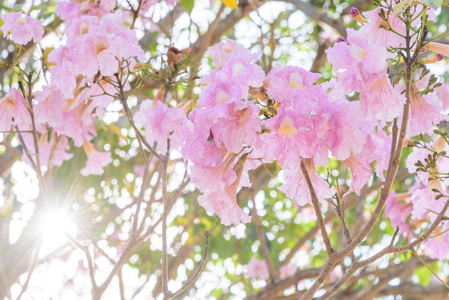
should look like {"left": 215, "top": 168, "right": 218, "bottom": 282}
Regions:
{"left": 0, "top": 88, "right": 31, "bottom": 131}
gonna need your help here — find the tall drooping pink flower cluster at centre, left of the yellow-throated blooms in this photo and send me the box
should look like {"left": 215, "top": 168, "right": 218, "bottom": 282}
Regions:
{"left": 182, "top": 40, "right": 265, "bottom": 225}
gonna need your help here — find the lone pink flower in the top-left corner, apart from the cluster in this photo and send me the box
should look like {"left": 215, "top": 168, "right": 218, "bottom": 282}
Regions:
{"left": 0, "top": 12, "right": 44, "bottom": 45}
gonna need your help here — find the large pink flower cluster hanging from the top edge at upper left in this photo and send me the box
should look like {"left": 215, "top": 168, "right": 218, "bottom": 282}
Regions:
{"left": 46, "top": 1, "right": 144, "bottom": 175}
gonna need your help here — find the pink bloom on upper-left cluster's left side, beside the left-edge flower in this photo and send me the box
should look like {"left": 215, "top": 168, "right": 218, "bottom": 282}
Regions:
{"left": 33, "top": 86, "right": 67, "bottom": 126}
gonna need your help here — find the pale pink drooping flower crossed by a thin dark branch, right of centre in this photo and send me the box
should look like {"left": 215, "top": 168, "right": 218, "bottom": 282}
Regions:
{"left": 279, "top": 159, "right": 335, "bottom": 206}
